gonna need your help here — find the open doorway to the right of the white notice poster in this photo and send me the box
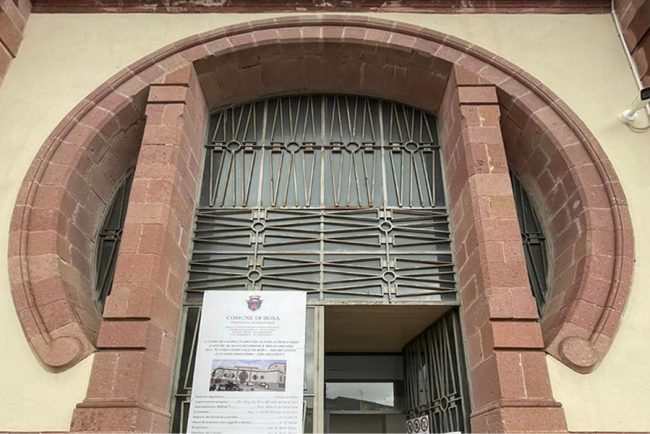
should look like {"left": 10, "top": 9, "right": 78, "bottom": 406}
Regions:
{"left": 323, "top": 305, "right": 469, "bottom": 433}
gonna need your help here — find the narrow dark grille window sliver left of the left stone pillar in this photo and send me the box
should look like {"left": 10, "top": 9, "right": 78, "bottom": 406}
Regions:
{"left": 95, "top": 170, "right": 133, "bottom": 311}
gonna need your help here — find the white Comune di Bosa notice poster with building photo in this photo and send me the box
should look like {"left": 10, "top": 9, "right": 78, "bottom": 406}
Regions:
{"left": 187, "top": 291, "right": 306, "bottom": 434}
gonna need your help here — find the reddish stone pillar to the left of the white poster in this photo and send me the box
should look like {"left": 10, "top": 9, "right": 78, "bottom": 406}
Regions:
{"left": 72, "top": 67, "right": 207, "bottom": 432}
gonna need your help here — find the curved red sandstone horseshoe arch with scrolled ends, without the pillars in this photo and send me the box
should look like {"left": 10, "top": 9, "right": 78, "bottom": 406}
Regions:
{"left": 9, "top": 16, "right": 633, "bottom": 372}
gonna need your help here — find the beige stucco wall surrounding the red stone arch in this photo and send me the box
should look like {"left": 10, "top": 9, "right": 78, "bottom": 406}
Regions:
{"left": 0, "top": 14, "right": 650, "bottom": 431}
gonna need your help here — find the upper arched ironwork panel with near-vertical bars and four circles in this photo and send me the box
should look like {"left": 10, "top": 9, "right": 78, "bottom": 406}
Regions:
{"left": 201, "top": 96, "right": 445, "bottom": 208}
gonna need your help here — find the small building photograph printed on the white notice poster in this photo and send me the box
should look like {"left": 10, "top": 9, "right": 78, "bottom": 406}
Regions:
{"left": 210, "top": 359, "right": 287, "bottom": 392}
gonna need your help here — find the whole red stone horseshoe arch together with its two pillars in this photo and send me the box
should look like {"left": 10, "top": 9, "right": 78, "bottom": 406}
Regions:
{"left": 10, "top": 16, "right": 632, "bottom": 431}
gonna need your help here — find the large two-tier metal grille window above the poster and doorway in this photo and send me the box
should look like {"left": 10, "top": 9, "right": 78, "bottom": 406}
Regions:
{"left": 188, "top": 96, "right": 456, "bottom": 302}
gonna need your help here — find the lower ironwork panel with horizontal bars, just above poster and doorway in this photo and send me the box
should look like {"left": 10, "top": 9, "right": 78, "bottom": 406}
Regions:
{"left": 188, "top": 209, "right": 455, "bottom": 301}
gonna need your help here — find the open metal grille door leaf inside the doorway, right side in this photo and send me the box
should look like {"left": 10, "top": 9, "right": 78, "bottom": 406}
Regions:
{"left": 404, "top": 310, "right": 470, "bottom": 433}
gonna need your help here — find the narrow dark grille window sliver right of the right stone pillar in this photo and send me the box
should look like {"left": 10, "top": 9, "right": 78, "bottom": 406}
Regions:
{"left": 510, "top": 171, "right": 548, "bottom": 316}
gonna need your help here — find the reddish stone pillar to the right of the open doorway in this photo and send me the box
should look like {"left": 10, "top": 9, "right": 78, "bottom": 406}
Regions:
{"left": 440, "top": 74, "right": 566, "bottom": 432}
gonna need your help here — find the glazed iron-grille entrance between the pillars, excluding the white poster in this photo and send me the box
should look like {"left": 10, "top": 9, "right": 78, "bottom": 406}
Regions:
{"left": 172, "top": 94, "right": 469, "bottom": 432}
